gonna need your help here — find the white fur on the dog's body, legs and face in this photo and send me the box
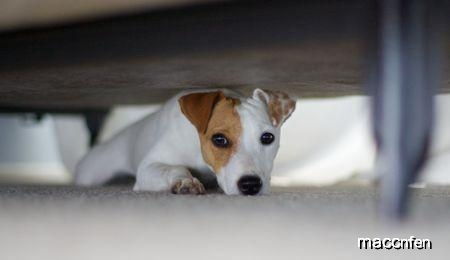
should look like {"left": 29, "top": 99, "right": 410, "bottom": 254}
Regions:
{"left": 75, "top": 89, "right": 293, "bottom": 194}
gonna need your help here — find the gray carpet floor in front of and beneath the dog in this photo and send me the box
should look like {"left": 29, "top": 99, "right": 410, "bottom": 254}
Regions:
{"left": 0, "top": 185, "right": 450, "bottom": 259}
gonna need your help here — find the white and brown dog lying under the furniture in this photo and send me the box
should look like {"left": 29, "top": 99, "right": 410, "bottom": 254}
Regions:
{"left": 75, "top": 89, "right": 295, "bottom": 195}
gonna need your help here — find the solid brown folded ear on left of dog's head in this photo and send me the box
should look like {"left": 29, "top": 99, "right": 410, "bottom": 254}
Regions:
{"left": 178, "top": 91, "right": 225, "bottom": 134}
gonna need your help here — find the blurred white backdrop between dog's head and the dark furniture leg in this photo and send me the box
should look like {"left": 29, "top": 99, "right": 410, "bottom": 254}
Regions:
{"left": 272, "top": 96, "right": 375, "bottom": 186}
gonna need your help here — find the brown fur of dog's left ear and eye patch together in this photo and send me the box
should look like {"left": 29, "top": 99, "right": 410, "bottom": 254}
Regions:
{"left": 179, "top": 91, "right": 242, "bottom": 173}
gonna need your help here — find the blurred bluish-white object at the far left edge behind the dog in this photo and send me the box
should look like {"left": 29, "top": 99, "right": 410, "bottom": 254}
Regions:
{"left": 0, "top": 114, "right": 72, "bottom": 184}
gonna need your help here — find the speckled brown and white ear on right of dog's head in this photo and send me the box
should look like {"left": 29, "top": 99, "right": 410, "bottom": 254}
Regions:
{"left": 253, "top": 88, "right": 295, "bottom": 127}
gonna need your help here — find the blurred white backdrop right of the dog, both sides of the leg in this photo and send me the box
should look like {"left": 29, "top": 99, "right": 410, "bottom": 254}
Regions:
{"left": 272, "top": 94, "right": 450, "bottom": 186}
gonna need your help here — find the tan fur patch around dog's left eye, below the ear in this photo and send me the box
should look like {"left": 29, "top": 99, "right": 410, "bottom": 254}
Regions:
{"left": 199, "top": 98, "right": 242, "bottom": 173}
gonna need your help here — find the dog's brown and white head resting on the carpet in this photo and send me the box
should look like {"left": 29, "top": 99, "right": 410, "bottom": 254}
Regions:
{"left": 179, "top": 89, "right": 295, "bottom": 195}
